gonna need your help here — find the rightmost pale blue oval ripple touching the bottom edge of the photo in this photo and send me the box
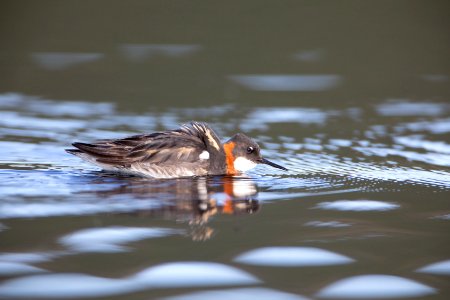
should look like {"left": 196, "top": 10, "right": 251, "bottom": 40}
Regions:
{"left": 317, "top": 274, "right": 437, "bottom": 299}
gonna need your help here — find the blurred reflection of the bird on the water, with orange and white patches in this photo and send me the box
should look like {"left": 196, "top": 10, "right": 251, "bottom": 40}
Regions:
{"left": 87, "top": 174, "right": 260, "bottom": 240}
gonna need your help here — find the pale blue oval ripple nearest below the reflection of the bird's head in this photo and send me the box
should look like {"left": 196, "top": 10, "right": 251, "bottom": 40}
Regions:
{"left": 234, "top": 247, "right": 354, "bottom": 267}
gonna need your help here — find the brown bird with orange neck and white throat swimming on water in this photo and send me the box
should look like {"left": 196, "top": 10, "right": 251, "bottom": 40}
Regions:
{"left": 66, "top": 121, "right": 288, "bottom": 178}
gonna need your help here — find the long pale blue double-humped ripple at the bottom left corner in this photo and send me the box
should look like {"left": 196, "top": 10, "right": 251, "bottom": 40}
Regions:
{"left": 0, "top": 262, "right": 261, "bottom": 299}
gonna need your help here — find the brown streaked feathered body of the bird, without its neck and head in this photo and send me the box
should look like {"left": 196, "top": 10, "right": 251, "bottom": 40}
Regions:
{"left": 66, "top": 122, "right": 225, "bottom": 178}
